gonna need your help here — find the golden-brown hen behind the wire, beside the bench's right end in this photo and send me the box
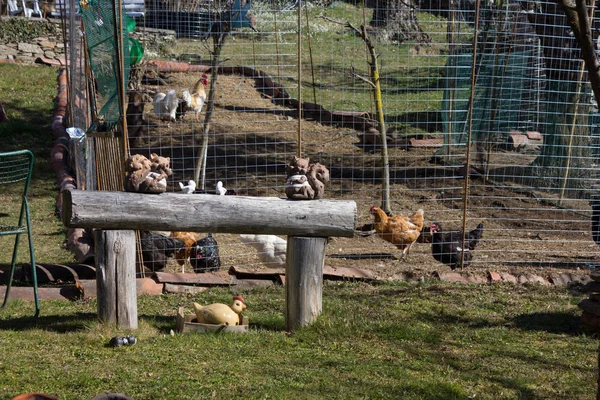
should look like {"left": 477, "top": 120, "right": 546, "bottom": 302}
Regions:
{"left": 370, "top": 206, "right": 424, "bottom": 258}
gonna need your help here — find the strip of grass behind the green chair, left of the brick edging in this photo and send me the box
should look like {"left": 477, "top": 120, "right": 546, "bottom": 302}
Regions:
{"left": 0, "top": 64, "right": 74, "bottom": 266}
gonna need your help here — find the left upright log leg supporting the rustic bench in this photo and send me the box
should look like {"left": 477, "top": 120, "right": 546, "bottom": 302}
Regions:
{"left": 94, "top": 230, "right": 138, "bottom": 329}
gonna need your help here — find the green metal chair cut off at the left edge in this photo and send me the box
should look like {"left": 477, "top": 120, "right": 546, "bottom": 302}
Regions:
{"left": 0, "top": 150, "right": 40, "bottom": 317}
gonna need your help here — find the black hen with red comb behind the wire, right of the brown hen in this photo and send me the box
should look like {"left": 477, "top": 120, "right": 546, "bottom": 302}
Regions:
{"left": 430, "top": 222, "right": 483, "bottom": 269}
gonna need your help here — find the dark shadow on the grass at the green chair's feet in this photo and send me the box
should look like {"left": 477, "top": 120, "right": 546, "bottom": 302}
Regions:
{"left": 0, "top": 311, "right": 98, "bottom": 333}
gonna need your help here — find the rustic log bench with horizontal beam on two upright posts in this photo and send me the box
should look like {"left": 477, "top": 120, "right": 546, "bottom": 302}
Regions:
{"left": 62, "top": 189, "right": 356, "bottom": 331}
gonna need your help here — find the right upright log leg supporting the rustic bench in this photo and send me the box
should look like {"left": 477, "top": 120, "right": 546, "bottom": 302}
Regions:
{"left": 285, "top": 236, "right": 327, "bottom": 331}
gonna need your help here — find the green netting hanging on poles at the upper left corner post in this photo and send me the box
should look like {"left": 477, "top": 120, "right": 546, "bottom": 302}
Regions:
{"left": 79, "top": 0, "right": 135, "bottom": 131}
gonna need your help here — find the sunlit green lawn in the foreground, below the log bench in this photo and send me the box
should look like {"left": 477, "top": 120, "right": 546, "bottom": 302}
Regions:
{"left": 0, "top": 282, "right": 597, "bottom": 400}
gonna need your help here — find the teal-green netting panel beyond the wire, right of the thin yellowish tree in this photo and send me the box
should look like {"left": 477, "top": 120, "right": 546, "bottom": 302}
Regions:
{"left": 442, "top": 51, "right": 540, "bottom": 144}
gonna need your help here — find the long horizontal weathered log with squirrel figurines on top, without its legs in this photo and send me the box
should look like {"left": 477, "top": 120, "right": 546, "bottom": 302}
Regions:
{"left": 62, "top": 189, "right": 356, "bottom": 237}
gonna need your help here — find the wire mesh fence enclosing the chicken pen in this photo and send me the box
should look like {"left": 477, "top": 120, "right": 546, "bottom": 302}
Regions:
{"left": 59, "top": 0, "right": 600, "bottom": 275}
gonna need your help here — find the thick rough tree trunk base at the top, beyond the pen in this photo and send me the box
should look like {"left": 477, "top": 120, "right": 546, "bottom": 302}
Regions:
{"left": 366, "top": 0, "right": 431, "bottom": 44}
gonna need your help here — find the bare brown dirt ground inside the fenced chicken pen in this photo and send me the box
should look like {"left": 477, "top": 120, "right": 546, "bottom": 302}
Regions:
{"left": 125, "top": 70, "right": 598, "bottom": 279}
